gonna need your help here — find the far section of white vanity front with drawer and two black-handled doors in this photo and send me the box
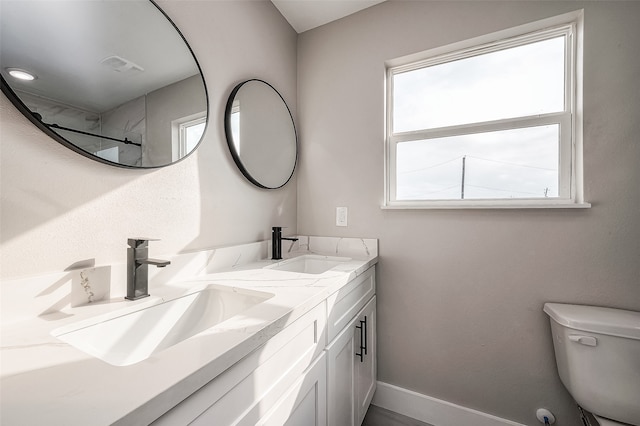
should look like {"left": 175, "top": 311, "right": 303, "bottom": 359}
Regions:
{"left": 327, "top": 268, "right": 377, "bottom": 426}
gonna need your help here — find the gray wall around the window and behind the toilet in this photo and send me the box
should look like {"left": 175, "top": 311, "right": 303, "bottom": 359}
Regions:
{"left": 298, "top": 0, "right": 640, "bottom": 426}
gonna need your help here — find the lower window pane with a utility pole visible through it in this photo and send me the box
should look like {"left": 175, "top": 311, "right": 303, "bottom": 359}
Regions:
{"left": 396, "top": 125, "right": 559, "bottom": 200}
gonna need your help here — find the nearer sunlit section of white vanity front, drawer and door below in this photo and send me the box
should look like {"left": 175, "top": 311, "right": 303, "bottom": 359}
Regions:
{"left": 153, "top": 302, "right": 327, "bottom": 426}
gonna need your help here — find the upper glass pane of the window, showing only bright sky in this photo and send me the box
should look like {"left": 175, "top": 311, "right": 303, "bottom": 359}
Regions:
{"left": 393, "top": 35, "right": 566, "bottom": 133}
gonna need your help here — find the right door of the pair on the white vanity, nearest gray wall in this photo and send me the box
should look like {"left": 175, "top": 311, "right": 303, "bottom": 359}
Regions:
{"left": 354, "top": 296, "right": 377, "bottom": 425}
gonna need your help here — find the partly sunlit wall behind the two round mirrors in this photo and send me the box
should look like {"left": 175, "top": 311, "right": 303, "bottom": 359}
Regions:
{"left": 0, "top": 1, "right": 297, "bottom": 278}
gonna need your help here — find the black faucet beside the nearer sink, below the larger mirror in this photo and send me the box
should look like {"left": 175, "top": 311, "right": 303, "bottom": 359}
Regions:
{"left": 125, "top": 238, "right": 171, "bottom": 300}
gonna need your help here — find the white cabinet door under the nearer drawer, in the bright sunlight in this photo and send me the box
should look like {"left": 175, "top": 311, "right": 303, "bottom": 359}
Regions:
{"left": 257, "top": 354, "right": 327, "bottom": 426}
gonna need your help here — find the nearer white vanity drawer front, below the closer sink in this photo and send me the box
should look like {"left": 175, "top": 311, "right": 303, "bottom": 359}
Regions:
{"left": 153, "top": 303, "right": 326, "bottom": 426}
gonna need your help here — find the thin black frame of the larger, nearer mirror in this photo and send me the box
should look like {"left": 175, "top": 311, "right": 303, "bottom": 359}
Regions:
{"left": 0, "top": 0, "right": 210, "bottom": 169}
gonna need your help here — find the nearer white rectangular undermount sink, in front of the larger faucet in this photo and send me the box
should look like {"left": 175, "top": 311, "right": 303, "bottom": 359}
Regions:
{"left": 51, "top": 284, "right": 273, "bottom": 366}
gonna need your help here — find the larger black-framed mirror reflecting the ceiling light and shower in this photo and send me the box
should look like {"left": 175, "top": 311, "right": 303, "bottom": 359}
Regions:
{"left": 0, "top": 0, "right": 208, "bottom": 168}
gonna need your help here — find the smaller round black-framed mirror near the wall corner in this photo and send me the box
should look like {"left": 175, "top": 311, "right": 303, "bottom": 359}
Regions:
{"left": 224, "top": 79, "right": 298, "bottom": 189}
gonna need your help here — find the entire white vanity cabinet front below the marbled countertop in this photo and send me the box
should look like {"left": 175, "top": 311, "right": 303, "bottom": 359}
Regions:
{"left": 153, "top": 267, "right": 376, "bottom": 426}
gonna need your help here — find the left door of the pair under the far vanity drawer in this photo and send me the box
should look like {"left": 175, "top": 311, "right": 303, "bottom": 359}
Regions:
{"left": 327, "top": 318, "right": 360, "bottom": 426}
